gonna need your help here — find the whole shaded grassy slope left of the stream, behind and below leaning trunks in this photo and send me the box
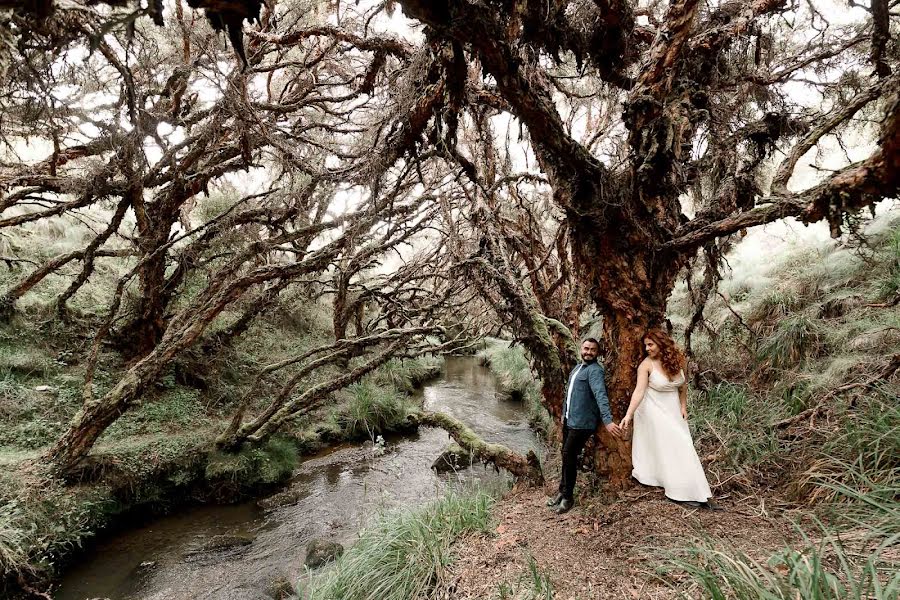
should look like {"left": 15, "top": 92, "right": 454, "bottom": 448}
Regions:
{"left": 0, "top": 294, "right": 440, "bottom": 594}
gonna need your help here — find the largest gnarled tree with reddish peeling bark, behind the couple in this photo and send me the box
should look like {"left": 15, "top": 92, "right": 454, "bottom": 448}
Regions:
{"left": 7, "top": 0, "right": 900, "bottom": 481}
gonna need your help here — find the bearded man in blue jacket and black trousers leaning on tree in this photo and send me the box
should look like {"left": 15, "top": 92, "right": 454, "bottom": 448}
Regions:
{"left": 547, "top": 338, "right": 622, "bottom": 514}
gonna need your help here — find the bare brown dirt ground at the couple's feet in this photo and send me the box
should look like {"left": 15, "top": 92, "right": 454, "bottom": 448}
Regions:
{"left": 446, "top": 482, "right": 793, "bottom": 600}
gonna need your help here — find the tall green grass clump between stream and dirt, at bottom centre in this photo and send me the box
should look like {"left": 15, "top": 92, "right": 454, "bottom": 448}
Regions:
{"left": 305, "top": 490, "right": 493, "bottom": 600}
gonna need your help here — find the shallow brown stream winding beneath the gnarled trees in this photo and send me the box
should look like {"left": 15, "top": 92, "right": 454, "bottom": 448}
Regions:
{"left": 54, "top": 357, "right": 538, "bottom": 600}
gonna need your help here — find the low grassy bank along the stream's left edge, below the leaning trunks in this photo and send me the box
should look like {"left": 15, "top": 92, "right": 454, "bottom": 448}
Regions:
{"left": 0, "top": 360, "right": 441, "bottom": 599}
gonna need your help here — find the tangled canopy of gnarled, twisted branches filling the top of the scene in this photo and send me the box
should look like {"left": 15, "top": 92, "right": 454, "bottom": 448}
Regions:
{"left": 0, "top": 0, "right": 900, "bottom": 476}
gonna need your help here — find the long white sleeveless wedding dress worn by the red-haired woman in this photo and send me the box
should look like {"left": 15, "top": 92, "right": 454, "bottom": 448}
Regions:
{"left": 631, "top": 369, "right": 712, "bottom": 502}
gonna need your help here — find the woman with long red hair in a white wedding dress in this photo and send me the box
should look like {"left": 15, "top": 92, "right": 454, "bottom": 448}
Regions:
{"left": 621, "top": 329, "right": 712, "bottom": 504}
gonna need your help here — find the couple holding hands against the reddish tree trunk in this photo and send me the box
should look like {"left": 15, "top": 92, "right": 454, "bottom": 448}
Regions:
{"left": 547, "top": 329, "right": 712, "bottom": 514}
